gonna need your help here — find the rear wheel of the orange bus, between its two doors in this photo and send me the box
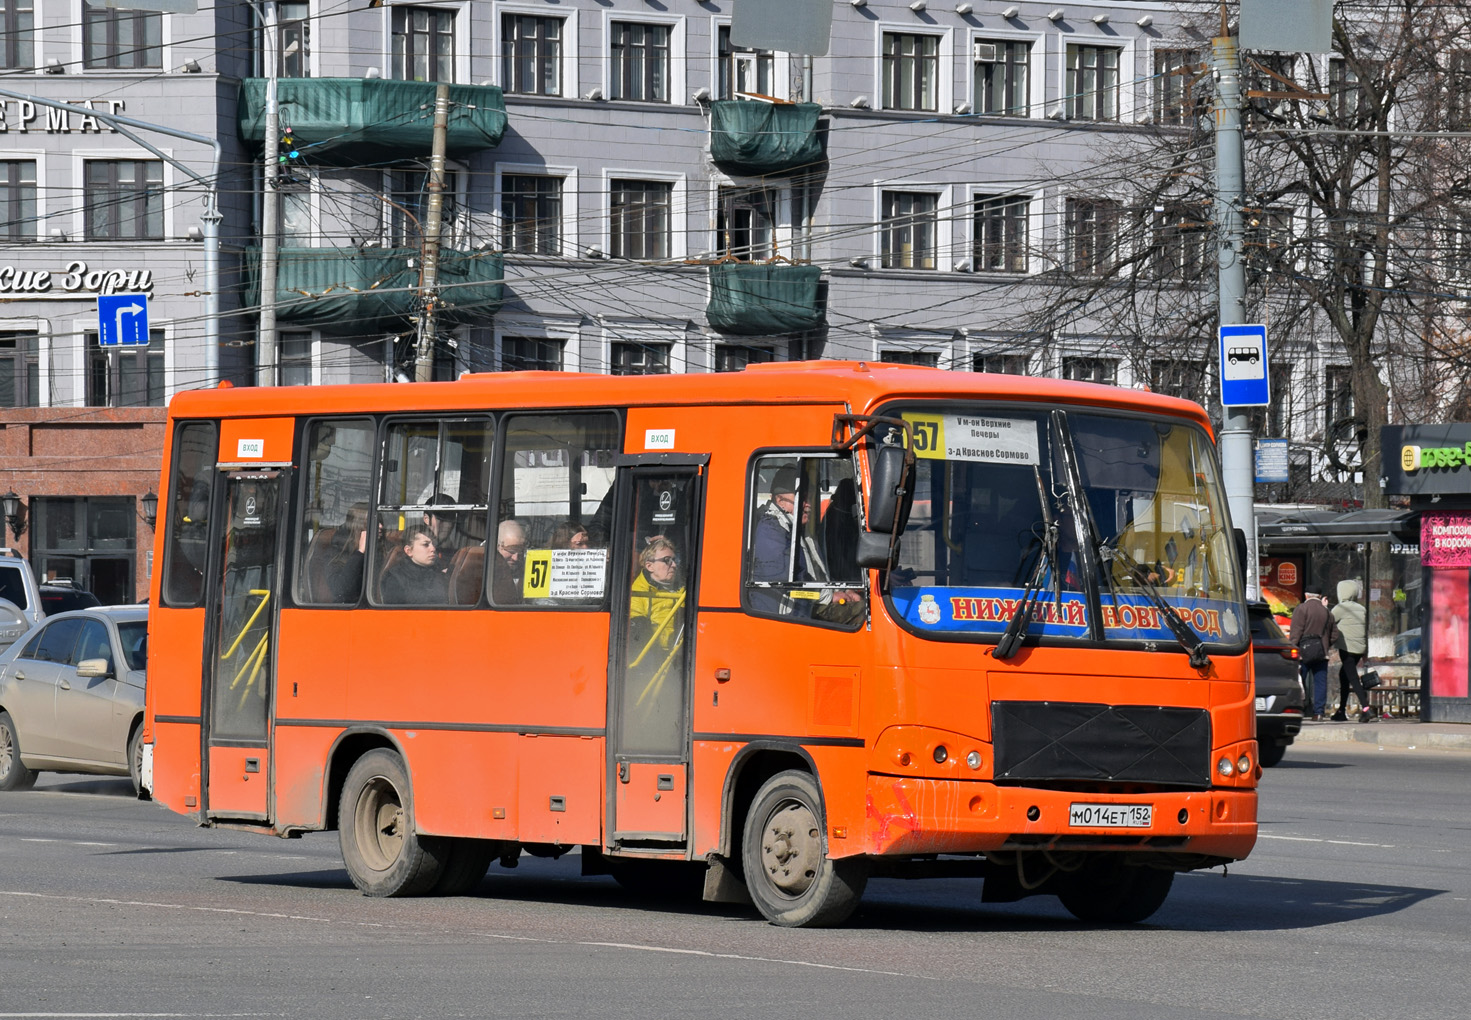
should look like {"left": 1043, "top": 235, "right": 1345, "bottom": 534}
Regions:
{"left": 337, "top": 748, "right": 447, "bottom": 896}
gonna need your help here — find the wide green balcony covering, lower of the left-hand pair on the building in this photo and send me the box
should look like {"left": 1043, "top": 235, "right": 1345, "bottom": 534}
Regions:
{"left": 246, "top": 247, "right": 505, "bottom": 334}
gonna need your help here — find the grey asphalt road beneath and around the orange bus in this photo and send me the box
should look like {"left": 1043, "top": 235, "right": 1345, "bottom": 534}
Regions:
{"left": 0, "top": 746, "right": 1471, "bottom": 1020}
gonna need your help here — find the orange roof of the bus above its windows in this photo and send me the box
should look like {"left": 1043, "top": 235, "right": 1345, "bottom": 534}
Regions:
{"left": 169, "top": 361, "right": 1209, "bottom": 428}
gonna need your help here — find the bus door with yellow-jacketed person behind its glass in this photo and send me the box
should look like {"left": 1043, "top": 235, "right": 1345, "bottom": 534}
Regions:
{"left": 608, "top": 455, "right": 703, "bottom": 851}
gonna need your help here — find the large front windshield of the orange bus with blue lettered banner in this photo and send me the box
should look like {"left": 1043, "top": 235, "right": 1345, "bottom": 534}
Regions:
{"left": 890, "top": 405, "right": 1246, "bottom": 651}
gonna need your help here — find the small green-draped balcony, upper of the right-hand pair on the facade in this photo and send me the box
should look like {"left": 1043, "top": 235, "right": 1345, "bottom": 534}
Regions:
{"left": 710, "top": 99, "right": 824, "bottom": 177}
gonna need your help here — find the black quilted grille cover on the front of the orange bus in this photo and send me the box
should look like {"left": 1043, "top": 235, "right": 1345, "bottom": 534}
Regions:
{"left": 991, "top": 701, "right": 1211, "bottom": 787}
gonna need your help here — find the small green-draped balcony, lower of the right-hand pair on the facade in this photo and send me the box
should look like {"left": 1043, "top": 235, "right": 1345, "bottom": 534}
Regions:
{"left": 705, "top": 262, "right": 825, "bottom": 337}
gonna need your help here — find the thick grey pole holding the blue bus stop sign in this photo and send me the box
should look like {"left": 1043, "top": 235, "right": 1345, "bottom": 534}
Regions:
{"left": 1211, "top": 27, "right": 1261, "bottom": 599}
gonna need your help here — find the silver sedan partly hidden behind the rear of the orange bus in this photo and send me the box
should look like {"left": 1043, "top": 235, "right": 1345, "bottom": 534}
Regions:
{"left": 0, "top": 605, "right": 149, "bottom": 792}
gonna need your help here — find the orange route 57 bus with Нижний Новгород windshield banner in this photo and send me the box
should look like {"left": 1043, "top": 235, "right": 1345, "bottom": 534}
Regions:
{"left": 144, "top": 362, "right": 1261, "bottom": 926}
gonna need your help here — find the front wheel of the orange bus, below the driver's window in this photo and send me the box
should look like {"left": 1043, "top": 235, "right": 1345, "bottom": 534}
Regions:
{"left": 741, "top": 771, "right": 868, "bottom": 927}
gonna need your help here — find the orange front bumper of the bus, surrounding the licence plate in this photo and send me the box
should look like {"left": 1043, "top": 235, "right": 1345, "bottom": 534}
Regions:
{"left": 865, "top": 774, "right": 1256, "bottom": 860}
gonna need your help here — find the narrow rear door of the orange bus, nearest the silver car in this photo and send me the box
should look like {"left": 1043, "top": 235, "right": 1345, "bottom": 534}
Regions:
{"left": 204, "top": 470, "right": 287, "bottom": 821}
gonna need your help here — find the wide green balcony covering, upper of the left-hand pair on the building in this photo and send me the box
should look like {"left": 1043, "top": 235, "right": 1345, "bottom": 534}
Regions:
{"left": 237, "top": 78, "right": 506, "bottom": 165}
